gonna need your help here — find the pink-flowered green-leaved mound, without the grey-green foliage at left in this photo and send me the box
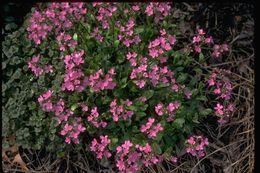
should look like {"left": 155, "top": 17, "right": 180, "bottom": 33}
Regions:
{"left": 3, "top": 3, "right": 235, "bottom": 172}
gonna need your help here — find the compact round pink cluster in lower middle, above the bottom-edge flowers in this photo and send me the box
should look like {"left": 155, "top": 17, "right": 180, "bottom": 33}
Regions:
{"left": 140, "top": 118, "right": 163, "bottom": 139}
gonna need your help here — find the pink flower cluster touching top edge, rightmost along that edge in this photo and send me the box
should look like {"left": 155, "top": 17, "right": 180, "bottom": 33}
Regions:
{"left": 145, "top": 2, "right": 171, "bottom": 23}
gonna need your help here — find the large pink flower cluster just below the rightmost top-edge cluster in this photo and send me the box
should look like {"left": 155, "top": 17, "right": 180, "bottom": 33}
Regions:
{"left": 148, "top": 29, "right": 176, "bottom": 59}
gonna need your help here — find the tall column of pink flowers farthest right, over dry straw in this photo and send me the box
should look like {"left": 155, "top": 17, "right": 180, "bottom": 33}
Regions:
{"left": 208, "top": 68, "right": 234, "bottom": 123}
